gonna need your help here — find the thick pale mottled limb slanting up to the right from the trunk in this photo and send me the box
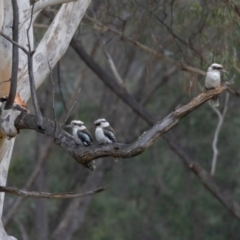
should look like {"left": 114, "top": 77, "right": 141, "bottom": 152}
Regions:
{"left": 18, "top": 0, "right": 91, "bottom": 101}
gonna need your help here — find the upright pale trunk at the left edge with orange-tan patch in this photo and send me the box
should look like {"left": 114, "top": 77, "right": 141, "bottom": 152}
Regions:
{"left": 0, "top": 0, "right": 33, "bottom": 240}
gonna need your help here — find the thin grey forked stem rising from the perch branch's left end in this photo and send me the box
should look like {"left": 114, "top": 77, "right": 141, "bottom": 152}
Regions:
{"left": 27, "top": 4, "right": 43, "bottom": 128}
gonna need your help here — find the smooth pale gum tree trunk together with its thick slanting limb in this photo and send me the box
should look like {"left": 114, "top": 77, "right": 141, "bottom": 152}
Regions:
{"left": 0, "top": 0, "right": 91, "bottom": 240}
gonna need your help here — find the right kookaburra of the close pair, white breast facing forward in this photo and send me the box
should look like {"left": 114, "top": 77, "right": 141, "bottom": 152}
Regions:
{"left": 94, "top": 118, "right": 118, "bottom": 162}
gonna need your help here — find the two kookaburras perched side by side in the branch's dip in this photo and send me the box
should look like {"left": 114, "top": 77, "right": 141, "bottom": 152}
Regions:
{"left": 66, "top": 118, "right": 116, "bottom": 147}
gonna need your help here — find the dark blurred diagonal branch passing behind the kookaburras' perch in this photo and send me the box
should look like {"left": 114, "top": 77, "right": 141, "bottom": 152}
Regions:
{"left": 71, "top": 34, "right": 240, "bottom": 223}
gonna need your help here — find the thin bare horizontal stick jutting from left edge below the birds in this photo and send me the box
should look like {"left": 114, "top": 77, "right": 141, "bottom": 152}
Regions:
{"left": 0, "top": 186, "right": 106, "bottom": 199}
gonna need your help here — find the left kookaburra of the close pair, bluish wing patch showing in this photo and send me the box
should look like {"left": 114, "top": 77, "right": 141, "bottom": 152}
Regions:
{"left": 66, "top": 120, "right": 93, "bottom": 147}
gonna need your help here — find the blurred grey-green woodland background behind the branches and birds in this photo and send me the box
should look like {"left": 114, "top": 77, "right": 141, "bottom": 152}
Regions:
{"left": 3, "top": 0, "right": 240, "bottom": 240}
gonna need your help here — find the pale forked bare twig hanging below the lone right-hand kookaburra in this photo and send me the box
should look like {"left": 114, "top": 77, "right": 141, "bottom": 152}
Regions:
{"left": 209, "top": 92, "right": 229, "bottom": 176}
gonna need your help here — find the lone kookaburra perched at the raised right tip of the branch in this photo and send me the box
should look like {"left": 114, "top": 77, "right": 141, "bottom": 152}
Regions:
{"left": 205, "top": 63, "right": 227, "bottom": 107}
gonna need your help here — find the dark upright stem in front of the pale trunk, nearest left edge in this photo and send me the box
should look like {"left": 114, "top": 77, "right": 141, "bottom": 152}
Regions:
{"left": 5, "top": 0, "right": 19, "bottom": 109}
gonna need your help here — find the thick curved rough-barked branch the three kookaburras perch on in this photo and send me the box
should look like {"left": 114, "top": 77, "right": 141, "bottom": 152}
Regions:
{"left": 15, "top": 83, "right": 229, "bottom": 164}
